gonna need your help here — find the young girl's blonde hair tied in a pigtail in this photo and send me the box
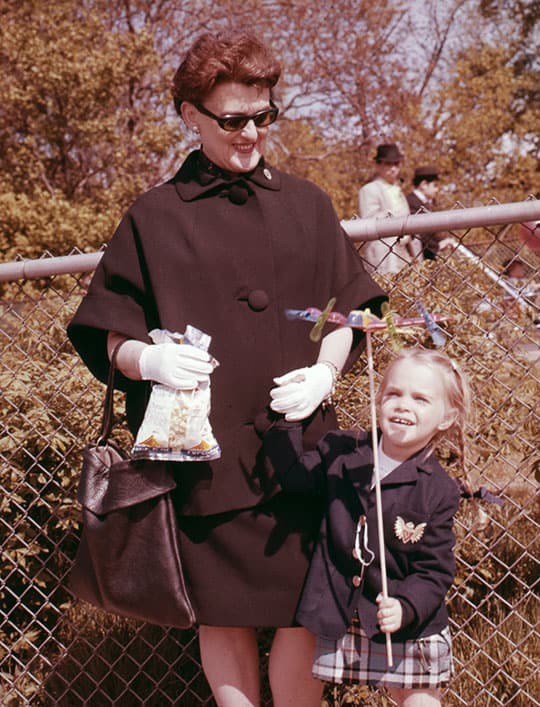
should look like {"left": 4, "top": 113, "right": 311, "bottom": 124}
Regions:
{"left": 376, "top": 347, "right": 471, "bottom": 477}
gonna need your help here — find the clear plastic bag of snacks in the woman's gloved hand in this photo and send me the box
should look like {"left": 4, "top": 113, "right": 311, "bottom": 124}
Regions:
{"left": 131, "top": 325, "right": 221, "bottom": 461}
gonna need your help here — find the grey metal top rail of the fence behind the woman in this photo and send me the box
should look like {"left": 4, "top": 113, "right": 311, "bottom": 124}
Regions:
{"left": 0, "top": 199, "right": 540, "bottom": 282}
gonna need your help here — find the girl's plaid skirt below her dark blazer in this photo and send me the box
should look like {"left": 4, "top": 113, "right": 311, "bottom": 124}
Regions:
{"left": 313, "top": 619, "right": 452, "bottom": 689}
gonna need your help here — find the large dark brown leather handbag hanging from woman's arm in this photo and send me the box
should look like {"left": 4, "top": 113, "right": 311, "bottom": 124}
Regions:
{"left": 68, "top": 347, "right": 195, "bottom": 628}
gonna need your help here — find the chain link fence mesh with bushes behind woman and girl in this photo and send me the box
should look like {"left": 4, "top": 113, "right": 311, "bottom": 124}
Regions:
{"left": 0, "top": 202, "right": 540, "bottom": 707}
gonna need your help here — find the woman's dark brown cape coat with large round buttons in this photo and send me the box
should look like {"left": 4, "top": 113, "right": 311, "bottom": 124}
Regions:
{"left": 68, "top": 151, "right": 385, "bottom": 515}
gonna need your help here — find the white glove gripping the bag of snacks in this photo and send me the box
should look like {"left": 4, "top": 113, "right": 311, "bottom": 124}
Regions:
{"left": 139, "top": 343, "right": 214, "bottom": 390}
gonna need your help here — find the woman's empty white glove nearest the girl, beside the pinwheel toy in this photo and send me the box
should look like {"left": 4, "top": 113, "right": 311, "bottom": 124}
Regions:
{"left": 270, "top": 363, "right": 335, "bottom": 422}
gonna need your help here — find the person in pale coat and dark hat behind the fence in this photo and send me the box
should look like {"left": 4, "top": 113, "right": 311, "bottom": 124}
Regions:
{"left": 359, "top": 143, "right": 421, "bottom": 274}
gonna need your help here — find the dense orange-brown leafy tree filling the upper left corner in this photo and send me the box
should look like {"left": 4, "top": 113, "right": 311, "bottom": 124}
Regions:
{"left": 0, "top": 0, "right": 180, "bottom": 255}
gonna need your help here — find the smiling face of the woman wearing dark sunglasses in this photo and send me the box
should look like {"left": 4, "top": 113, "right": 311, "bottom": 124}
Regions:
{"left": 182, "top": 82, "right": 270, "bottom": 172}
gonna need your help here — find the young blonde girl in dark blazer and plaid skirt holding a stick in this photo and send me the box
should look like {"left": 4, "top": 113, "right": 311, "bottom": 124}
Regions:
{"left": 265, "top": 348, "right": 470, "bottom": 707}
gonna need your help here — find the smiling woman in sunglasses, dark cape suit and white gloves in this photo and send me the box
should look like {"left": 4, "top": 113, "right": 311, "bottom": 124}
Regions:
{"left": 68, "top": 29, "right": 384, "bottom": 707}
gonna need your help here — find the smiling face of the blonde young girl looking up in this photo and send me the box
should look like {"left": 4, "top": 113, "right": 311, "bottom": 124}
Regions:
{"left": 379, "top": 360, "right": 455, "bottom": 461}
